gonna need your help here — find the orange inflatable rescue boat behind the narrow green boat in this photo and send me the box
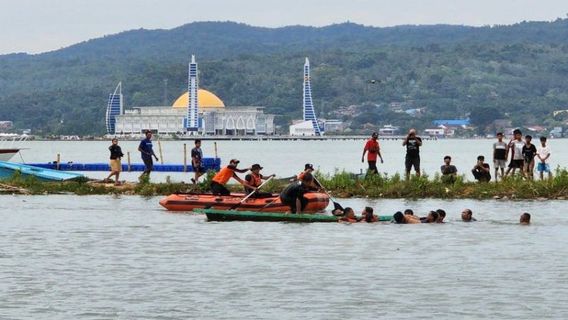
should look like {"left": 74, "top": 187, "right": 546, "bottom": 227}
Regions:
{"left": 160, "top": 192, "right": 329, "bottom": 213}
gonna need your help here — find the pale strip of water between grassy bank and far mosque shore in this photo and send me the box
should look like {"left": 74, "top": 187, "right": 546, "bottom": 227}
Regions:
{"left": 12, "top": 139, "right": 568, "bottom": 182}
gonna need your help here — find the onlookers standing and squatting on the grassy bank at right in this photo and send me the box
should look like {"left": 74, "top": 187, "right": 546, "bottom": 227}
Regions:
{"left": 361, "top": 129, "right": 552, "bottom": 183}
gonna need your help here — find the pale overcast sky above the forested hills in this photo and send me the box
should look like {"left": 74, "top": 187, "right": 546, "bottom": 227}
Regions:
{"left": 0, "top": 0, "right": 568, "bottom": 54}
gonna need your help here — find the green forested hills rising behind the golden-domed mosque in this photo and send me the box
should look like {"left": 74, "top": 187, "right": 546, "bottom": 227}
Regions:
{"left": 0, "top": 19, "right": 568, "bottom": 134}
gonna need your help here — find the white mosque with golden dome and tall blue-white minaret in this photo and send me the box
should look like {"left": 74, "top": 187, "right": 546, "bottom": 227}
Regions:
{"left": 106, "top": 56, "right": 275, "bottom": 136}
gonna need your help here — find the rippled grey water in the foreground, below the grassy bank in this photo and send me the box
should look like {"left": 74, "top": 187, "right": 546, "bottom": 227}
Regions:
{"left": 0, "top": 196, "right": 568, "bottom": 320}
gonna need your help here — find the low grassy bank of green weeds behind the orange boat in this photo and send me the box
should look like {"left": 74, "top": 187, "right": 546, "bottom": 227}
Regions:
{"left": 3, "top": 169, "right": 568, "bottom": 199}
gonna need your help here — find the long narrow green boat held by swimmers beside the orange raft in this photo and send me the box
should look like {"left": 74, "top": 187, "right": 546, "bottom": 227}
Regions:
{"left": 194, "top": 209, "right": 392, "bottom": 223}
